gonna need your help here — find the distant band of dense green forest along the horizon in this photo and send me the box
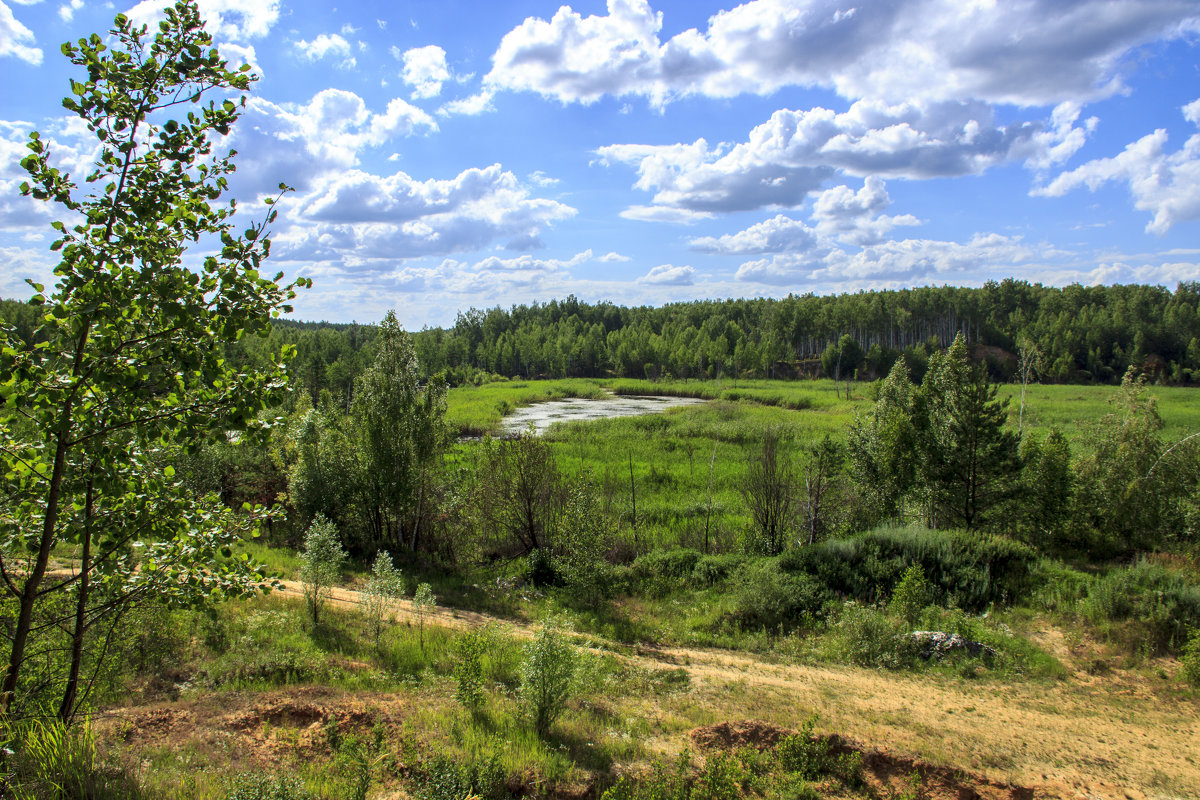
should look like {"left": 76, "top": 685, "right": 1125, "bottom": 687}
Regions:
{"left": 0, "top": 279, "right": 1200, "bottom": 399}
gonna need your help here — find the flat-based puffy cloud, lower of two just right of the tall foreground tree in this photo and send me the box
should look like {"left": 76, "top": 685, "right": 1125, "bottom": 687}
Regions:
{"left": 272, "top": 164, "right": 575, "bottom": 263}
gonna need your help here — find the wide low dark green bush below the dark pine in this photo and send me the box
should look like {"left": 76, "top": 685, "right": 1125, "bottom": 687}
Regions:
{"left": 780, "top": 528, "right": 1037, "bottom": 610}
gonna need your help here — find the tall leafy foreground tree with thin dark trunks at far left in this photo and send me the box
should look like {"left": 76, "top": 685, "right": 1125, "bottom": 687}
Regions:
{"left": 0, "top": 0, "right": 308, "bottom": 718}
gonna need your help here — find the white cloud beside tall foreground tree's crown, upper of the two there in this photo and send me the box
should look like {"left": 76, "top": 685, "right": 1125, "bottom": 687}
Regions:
{"left": 230, "top": 89, "right": 437, "bottom": 192}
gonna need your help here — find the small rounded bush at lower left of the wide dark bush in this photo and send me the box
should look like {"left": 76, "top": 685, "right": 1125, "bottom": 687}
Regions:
{"left": 733, "top": 559, "right": 830, "bottom": 631}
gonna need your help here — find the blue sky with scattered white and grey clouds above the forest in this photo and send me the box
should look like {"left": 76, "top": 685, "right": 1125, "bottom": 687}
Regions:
{"left": 0, "top": 0, "right": 1200, "bottom": 330}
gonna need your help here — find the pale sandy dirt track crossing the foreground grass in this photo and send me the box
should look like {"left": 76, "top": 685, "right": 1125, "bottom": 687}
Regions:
{"left": 267, "top": 582, "right": 1200, "bottom": 800}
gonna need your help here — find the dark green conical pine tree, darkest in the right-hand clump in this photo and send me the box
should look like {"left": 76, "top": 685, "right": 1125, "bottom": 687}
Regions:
{"left": 918, "top": 333, "right": 1020, "bottom": 530}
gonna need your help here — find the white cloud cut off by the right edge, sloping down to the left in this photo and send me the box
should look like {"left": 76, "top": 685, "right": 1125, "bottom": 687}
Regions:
{"left": 1031, "top": 100, "right": 1200, "bottom": 234}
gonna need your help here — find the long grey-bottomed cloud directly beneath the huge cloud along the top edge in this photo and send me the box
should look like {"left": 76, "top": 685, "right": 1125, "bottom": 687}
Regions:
{"left": 596, "top": 101, "right": 1079, "bottom": 217}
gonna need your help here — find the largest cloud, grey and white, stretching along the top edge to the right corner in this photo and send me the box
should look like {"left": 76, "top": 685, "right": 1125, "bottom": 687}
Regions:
{"left": 486, "top": 0, "right": 1200, "bottom": 106}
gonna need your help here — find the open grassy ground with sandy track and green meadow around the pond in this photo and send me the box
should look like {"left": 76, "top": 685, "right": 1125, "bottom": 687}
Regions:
{"left": 18, "top": 380, "right": 1200, "bottom": 800}
